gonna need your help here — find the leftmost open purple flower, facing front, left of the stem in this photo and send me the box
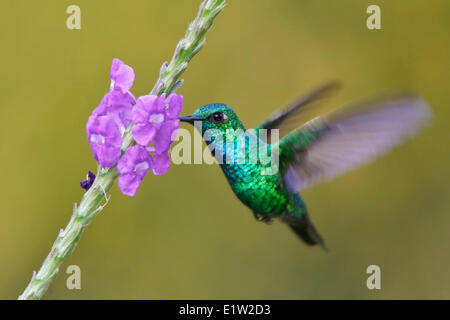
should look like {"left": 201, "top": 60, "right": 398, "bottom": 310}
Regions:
{"left": 86, "top": 114, "right": 122, "bottom": 168}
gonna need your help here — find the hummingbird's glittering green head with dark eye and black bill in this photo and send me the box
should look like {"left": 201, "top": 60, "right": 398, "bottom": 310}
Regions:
{"left": 180, "top": 103, "right": 244, "bottom": 135}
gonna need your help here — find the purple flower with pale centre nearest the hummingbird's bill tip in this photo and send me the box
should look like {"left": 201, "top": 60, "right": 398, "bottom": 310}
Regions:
{"left": 131, "top": 94, "right": 166, "bottom": 146}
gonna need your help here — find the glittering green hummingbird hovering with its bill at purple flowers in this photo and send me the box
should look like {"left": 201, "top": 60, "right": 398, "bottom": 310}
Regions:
{"left": 180, "top": 83, "right": 431, "bottom": 249}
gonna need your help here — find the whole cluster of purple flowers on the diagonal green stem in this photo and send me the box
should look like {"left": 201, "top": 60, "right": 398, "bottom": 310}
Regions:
{"left": 86, "top": 58, "right": 183, "bottom": 196}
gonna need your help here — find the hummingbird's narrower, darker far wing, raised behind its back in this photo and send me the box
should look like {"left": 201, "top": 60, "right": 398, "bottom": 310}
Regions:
{"left": 255, "top": 82, "right": 339, "bottom": 143}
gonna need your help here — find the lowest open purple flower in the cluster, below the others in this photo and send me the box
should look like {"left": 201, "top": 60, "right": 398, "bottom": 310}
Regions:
{"left": 117, "top": 145, "right": 152, "bottom": 196}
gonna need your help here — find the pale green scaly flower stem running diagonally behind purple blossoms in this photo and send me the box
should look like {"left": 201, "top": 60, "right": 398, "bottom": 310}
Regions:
{"left": 19, "top": 0, "right": 225, "bottom": 300}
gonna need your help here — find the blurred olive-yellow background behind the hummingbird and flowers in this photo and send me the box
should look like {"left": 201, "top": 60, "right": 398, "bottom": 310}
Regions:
{"left": 0, "top": 0, "right": 450, "bottom": 299}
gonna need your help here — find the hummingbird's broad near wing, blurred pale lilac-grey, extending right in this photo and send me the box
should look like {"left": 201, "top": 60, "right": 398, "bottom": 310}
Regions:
{"left": 274, "top": 95, "right": 431, "bottom": 192}
